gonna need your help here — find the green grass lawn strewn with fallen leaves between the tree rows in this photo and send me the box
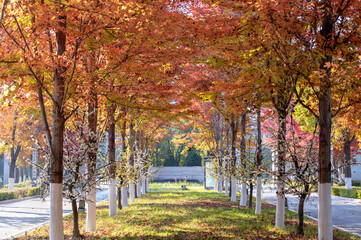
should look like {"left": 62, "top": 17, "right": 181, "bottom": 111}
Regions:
{"left": 18, "top": 183, "right": 361, "bottom": 240}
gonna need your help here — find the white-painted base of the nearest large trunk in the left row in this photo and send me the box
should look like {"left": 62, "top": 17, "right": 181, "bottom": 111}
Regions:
{"left": 49, "top": 183, "right": 64, "bottom": 240}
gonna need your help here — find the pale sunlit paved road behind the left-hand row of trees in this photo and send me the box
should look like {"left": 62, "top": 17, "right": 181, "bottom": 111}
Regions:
{"left": 0, "top": 189, "right": 108, "bottom": 239}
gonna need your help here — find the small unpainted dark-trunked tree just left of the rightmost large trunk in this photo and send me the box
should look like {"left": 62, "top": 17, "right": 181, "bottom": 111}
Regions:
{"left": 264, "top": 108, "right": 318, "bottom": 236}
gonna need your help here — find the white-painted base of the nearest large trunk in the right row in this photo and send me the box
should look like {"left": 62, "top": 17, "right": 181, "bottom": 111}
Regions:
{"left": 318, "top": 183, "right": 333, "bottom": 240}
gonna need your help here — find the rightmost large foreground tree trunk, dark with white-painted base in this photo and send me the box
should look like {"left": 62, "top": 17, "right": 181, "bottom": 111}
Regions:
{"left": 318, "top": 0, "right": 335, "bottom": 240}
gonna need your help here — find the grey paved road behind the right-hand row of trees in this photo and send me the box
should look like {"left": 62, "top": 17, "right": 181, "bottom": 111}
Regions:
{"left": 262, "top": 188, "right": 361, "bottom": 237}
